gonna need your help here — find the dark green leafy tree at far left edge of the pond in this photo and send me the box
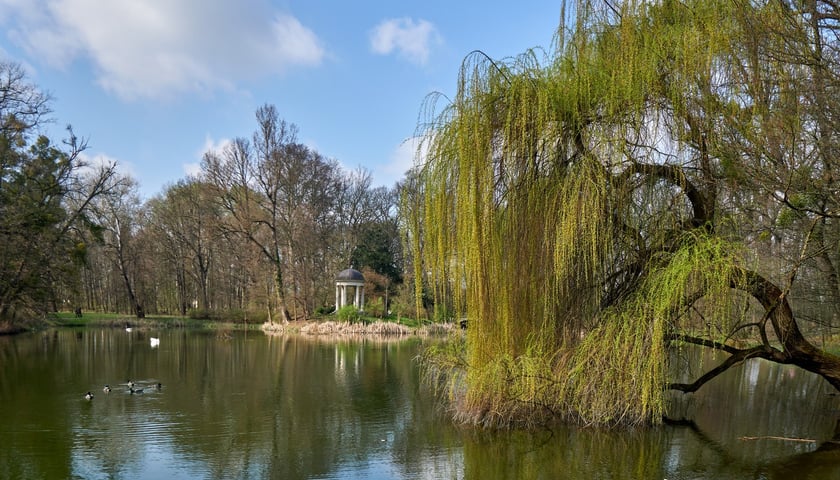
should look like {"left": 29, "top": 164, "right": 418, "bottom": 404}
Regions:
{"left": 0, "top": 62, "right": 124, "bottom": 322}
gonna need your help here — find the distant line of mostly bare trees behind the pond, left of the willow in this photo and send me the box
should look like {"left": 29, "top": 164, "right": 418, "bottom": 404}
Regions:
{"left": 0, "top": 63, "right": 415, "bottom": 322}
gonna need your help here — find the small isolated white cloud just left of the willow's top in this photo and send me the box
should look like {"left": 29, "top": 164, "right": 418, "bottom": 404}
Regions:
{"left": 370, "top": 17, "right": 443, "bottom": 65}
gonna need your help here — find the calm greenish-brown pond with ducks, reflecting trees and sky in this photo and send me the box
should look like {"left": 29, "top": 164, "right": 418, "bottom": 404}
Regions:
{"left": 0, "top": 329, "right": 840, "bottom": 480}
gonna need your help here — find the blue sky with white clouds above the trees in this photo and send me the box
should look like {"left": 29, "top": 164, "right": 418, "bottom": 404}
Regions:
{"left": 0, "top": 0, "right": 562, "bottom": 199}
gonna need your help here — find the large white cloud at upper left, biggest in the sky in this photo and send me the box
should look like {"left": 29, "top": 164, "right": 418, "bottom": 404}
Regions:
{"left": 0, "top": 0, "right": 324, "bottom": 99}
